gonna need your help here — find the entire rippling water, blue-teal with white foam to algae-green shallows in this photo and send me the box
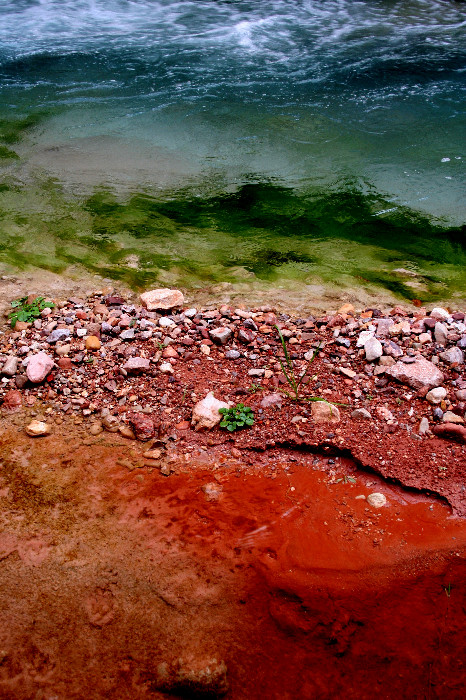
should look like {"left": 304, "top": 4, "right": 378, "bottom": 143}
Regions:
{"left": 0, "top": 0, "right": 466, "bottom": 300}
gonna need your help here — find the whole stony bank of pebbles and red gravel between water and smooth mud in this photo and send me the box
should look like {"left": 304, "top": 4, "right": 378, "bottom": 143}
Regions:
{"left": 0, "top": 290, "right": 466, "bottom": 515}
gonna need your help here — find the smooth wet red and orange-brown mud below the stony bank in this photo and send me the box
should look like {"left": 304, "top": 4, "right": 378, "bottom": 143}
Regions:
{"left": 0, "top": 424, "right": 466, "bottom": 700}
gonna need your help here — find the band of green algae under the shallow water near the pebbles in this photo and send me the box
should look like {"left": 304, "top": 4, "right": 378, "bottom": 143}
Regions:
{"left": 0, "top": 175, "right": 466, "bottom": 301}
